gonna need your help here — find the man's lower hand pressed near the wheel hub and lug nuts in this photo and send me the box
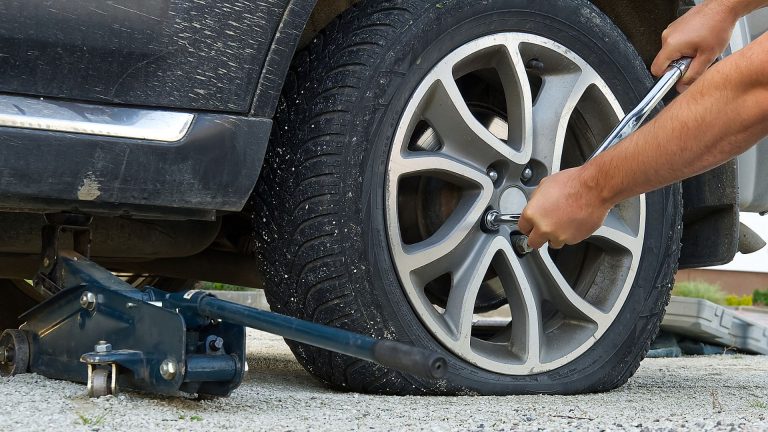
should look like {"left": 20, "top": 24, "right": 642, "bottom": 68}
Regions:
{"left": 518, "top": 168, "right": 613, "bottom": 249}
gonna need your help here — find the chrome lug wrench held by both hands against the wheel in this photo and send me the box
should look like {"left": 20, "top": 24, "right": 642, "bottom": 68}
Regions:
{"left": 482, "top": 57, "right": 692, "bottom": 255}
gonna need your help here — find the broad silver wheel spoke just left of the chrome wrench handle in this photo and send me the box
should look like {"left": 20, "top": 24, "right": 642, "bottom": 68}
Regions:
{"left": 532, "top": 70, "right": 597, "bottom": 174}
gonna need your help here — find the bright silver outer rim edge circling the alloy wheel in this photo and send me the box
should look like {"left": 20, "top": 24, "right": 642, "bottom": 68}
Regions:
{"left": 385, "top": 32, "right": 646, "bottom": 375}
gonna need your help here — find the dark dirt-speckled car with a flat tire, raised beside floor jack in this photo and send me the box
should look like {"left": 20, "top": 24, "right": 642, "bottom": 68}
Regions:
{"left": 0, "top": 0, "right": 768, "bottom": 395}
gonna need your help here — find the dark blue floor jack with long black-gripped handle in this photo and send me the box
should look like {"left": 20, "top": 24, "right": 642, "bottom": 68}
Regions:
{"left": 0, "top": 214, "right": 447, "bottom": 397}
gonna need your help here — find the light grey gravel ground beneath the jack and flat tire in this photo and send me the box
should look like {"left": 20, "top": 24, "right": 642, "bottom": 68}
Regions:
{"left": 0, "top": 331, "right": 768, "bottom": 431}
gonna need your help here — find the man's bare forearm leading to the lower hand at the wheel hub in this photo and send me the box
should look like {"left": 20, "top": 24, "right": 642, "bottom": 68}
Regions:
{"left": 582, "top": 31, "right": 768, "bottom": 208}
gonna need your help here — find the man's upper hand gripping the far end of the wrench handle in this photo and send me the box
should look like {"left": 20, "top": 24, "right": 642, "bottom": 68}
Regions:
{"left": 651, "top": 0, "right": 743, "bottom": 93}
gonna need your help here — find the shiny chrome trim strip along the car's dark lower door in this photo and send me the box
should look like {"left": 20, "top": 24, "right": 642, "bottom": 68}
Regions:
{"left": 0, "top": 95, "right": 195, "bottom": 142}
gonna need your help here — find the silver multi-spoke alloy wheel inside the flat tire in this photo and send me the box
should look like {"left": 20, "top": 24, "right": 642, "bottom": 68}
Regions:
{"left": 385, "top": 33, "right": 645, "bottom": 375}
